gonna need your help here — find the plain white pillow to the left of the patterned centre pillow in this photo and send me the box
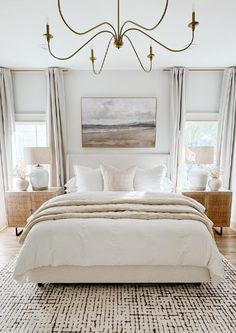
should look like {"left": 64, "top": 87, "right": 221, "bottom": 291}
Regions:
{"left": 74, "top": 165, "right": 103, "bottom": 192}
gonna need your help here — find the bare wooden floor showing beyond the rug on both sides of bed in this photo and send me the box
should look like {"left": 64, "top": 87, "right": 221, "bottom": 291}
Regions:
{"left": 0, "top": 228, "right": 236, "bottom": 269}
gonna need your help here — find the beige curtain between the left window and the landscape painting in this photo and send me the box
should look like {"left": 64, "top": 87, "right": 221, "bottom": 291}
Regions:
{"left": 46, "top": 68, "right": 66, "bottom": 186}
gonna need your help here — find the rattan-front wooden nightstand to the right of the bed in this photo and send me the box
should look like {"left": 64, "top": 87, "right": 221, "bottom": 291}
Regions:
{"left": 182, "top": 190, "right": 232, "bottom": 235}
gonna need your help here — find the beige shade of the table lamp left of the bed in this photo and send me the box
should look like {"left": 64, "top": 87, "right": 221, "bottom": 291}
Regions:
{"left": 24, "top": 147, "right": 52, "bottom": 165}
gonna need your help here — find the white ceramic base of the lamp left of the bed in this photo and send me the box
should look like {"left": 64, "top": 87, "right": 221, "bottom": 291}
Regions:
{"left": 29, "top": 165, "right": 49, "bottom": 191}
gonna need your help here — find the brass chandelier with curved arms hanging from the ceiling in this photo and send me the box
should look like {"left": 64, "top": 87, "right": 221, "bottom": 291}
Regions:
{"left": 44, "top": 0, "right": 199, "bottom": 74}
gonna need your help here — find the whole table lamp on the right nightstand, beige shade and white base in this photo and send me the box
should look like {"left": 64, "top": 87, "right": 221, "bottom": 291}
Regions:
{"left": 185, "top": 146, "right": 214, "bottom": 191}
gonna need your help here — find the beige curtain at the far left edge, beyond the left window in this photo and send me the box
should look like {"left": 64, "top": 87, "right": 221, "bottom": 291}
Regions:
{"left": 0, "top": 68, "right": 14, "bottom": 229}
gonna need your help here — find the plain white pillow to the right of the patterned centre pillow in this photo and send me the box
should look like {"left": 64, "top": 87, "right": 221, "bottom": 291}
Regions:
{"left": 134, "top": 165, "right": 167, "bottom": 192}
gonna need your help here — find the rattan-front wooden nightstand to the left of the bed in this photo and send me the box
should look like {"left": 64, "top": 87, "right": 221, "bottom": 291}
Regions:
{"left": 6, "top": 187, "right": 64, "bottom": 236}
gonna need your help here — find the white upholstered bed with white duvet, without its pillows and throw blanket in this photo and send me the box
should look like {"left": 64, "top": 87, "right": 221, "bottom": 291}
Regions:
{"left": 14, "top": 154, "right": 223, "bottom": 284}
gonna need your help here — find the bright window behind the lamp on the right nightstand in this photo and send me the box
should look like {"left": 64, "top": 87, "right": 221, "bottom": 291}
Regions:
{"left": 183, "top": 113, "right": 218, "bottom": 187}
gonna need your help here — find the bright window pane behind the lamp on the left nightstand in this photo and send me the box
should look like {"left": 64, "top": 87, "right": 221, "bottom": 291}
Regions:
{"left": 15, "top": 122, "right": 48, "bottom": 162}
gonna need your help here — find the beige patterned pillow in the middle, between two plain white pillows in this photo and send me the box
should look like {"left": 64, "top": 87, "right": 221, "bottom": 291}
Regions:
{"left": 100, "top": 165, "right": 136, "bottom": 191}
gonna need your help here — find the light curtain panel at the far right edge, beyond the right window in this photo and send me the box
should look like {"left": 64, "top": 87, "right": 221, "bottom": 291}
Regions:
{"left": 217, "top": 67, "right": 236, "bottom": 189}
